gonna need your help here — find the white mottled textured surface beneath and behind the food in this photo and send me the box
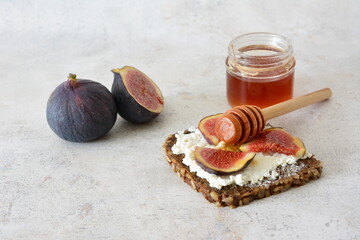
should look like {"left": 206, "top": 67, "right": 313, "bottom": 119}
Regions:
{"left": 0, "top": 0, "right": 360, "bottom": 240}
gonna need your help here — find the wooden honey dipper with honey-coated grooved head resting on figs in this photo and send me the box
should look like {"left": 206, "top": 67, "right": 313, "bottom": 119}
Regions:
{"left": 215, "top": 88, "right": 332, "bottom": 144}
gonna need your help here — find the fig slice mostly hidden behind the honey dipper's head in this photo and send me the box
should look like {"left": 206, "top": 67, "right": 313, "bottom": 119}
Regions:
{"left": 198, "top": 113, "right": 222, "bottom": 145}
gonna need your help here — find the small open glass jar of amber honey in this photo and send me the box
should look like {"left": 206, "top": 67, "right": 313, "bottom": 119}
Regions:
{"left": 226, "top": 32, "right": 295, "bottom": 108}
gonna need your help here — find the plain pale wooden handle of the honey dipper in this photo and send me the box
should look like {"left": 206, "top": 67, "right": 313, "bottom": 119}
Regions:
{"left": 262, "top": 88, "right": 332, "bottom": 120}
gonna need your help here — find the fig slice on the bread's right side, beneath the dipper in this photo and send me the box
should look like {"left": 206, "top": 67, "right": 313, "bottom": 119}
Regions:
{"left": 240, "top": 128, "right": 306, "bottom": 157}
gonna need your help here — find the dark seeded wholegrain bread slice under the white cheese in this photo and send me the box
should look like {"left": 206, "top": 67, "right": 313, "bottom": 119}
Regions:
{"left": 163, "top": 131, "right": 323, "bottom": 208}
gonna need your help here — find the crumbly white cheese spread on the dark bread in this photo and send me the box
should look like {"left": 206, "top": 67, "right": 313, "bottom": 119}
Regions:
{"left": 172, "top": 127, "right": 311, "bottom": 189}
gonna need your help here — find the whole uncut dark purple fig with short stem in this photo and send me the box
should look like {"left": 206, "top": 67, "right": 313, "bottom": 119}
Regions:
{"left": 46, "top": 74, "right": 117, "bottom": 142}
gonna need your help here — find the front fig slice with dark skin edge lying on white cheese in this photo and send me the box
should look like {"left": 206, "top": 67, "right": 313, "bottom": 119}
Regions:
{"left": 194, "top": 147, "right": 255, "bottom": 175}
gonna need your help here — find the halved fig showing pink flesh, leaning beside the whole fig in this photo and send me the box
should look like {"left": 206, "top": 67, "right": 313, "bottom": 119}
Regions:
{"left": 111, "top": 66, "right": 164, "bottom": 123}
